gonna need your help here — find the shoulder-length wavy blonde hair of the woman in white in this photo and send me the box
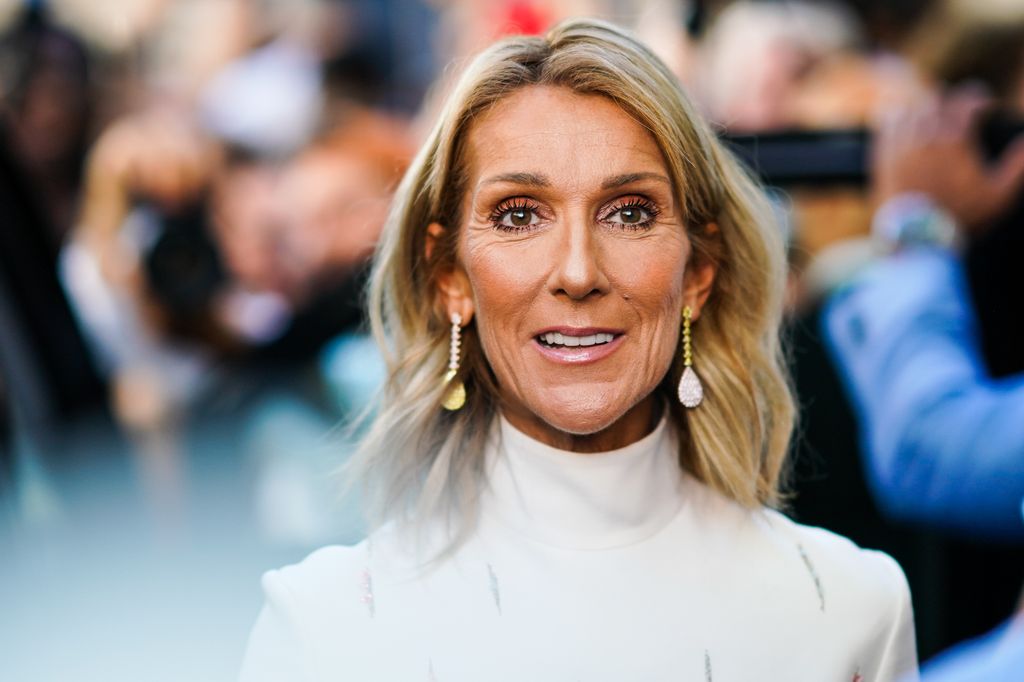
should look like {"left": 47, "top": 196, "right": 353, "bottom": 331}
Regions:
{"left": 350, "top": 14, "right": 795, "bottom": 544}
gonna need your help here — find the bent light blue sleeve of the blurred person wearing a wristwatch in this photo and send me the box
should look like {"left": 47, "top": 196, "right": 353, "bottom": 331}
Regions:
{"left": 824, "top": 249, "right": 1024, "bottom": 539}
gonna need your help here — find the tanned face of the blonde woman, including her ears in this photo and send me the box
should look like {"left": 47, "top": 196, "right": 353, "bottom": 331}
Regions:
{"left": 442, "top": 86, "right": 714, "bottom": 451}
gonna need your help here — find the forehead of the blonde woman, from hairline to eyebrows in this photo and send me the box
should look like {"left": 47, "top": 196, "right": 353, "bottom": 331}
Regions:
{"left": 466, "top": 85, "right": 669, "bottom": 193}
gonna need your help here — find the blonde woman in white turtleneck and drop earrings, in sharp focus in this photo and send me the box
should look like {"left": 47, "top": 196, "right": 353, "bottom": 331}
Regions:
{"left": 242, "top": 20, "right": 915, "bottom": 682}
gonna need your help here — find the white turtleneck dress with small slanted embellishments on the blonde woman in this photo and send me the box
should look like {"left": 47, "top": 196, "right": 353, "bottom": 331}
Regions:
{"left": 241, "top": 411, "right": 916, "bottom": 682}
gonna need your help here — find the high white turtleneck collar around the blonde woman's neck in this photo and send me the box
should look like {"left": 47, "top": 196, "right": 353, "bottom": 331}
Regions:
{"left": 483, "top": 409, "right": 683, "bottom": 550}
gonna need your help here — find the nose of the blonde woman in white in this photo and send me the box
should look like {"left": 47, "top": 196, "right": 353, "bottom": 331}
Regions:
{"left": 551, "top": 214, "right": 608, "bottom": 300}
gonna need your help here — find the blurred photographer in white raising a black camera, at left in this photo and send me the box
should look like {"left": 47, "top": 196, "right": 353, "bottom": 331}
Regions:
{"left": 62, "top": 111, "right": 224, "bottom": 427}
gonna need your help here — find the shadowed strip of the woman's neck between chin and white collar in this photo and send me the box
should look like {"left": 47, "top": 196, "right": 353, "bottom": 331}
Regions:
{"left": 503, "top": 395, "right": 662, "bottom": 453}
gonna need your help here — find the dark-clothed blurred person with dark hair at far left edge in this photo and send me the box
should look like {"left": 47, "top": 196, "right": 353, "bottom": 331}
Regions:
{"left": 0, "top": 3, "right": 103, "bottom": 432}
